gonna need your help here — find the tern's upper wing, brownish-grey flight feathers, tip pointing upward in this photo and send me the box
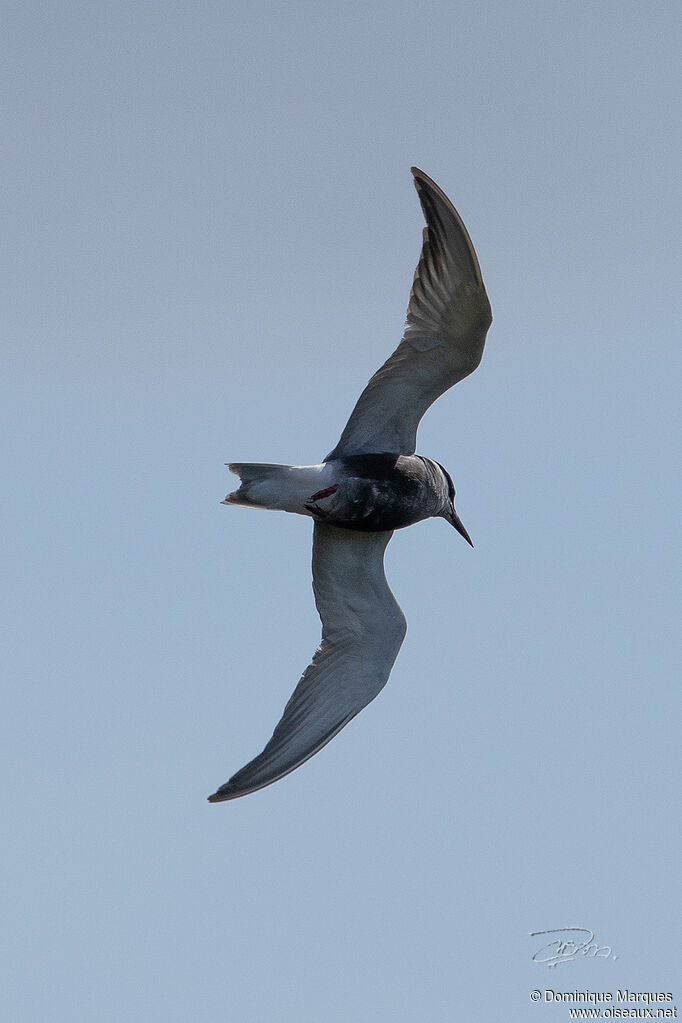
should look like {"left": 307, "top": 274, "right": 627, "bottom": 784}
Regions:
{"left": 327, "top": 167, "right": 493, "bottom": 460}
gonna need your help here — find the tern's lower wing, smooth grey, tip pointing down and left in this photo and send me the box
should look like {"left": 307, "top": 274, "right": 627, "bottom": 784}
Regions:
{"left": 209, "top": 523, "right": 407, "bottom": 803}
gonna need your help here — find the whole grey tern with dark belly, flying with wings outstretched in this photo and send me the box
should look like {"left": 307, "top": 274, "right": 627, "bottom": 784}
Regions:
{"left": 209, "top": 167, "right": 492, "bottom": 803}
